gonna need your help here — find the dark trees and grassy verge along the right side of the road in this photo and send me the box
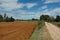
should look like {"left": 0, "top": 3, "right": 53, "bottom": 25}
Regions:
{"left": 40, "top": 15, "right": 60, "bottom": 27}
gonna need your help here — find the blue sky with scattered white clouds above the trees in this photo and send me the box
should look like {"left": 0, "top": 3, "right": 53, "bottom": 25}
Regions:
{"left": 0, "top": 0, "right": 60, "bottom": 19}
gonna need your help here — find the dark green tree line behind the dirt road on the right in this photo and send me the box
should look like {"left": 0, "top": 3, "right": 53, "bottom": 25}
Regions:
{"left": 40, "top": 15, "right": 60, "bottom": 22}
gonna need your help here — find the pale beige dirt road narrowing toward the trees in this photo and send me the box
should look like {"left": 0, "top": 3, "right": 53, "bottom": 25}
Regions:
{"left": 45, "top": 22, "right": 60, "bottom": 40}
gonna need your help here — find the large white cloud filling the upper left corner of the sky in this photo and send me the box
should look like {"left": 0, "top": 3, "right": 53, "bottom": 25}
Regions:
{"left": 0, "top": 0, "right": 24, "bottom": 10}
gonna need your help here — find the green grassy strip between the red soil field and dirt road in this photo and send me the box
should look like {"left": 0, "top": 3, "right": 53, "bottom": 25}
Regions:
{"left": 30, "top": 21, "right": 44, "bottom": 40}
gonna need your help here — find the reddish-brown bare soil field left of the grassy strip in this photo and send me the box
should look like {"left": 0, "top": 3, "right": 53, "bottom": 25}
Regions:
{"left": 0, "top": 22, "right": 38, "bottom": 40}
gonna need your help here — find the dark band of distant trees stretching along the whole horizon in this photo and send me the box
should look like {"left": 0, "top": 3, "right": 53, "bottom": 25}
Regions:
{"left": 0, "top": 14, "right": 60, "bottom": 22}
